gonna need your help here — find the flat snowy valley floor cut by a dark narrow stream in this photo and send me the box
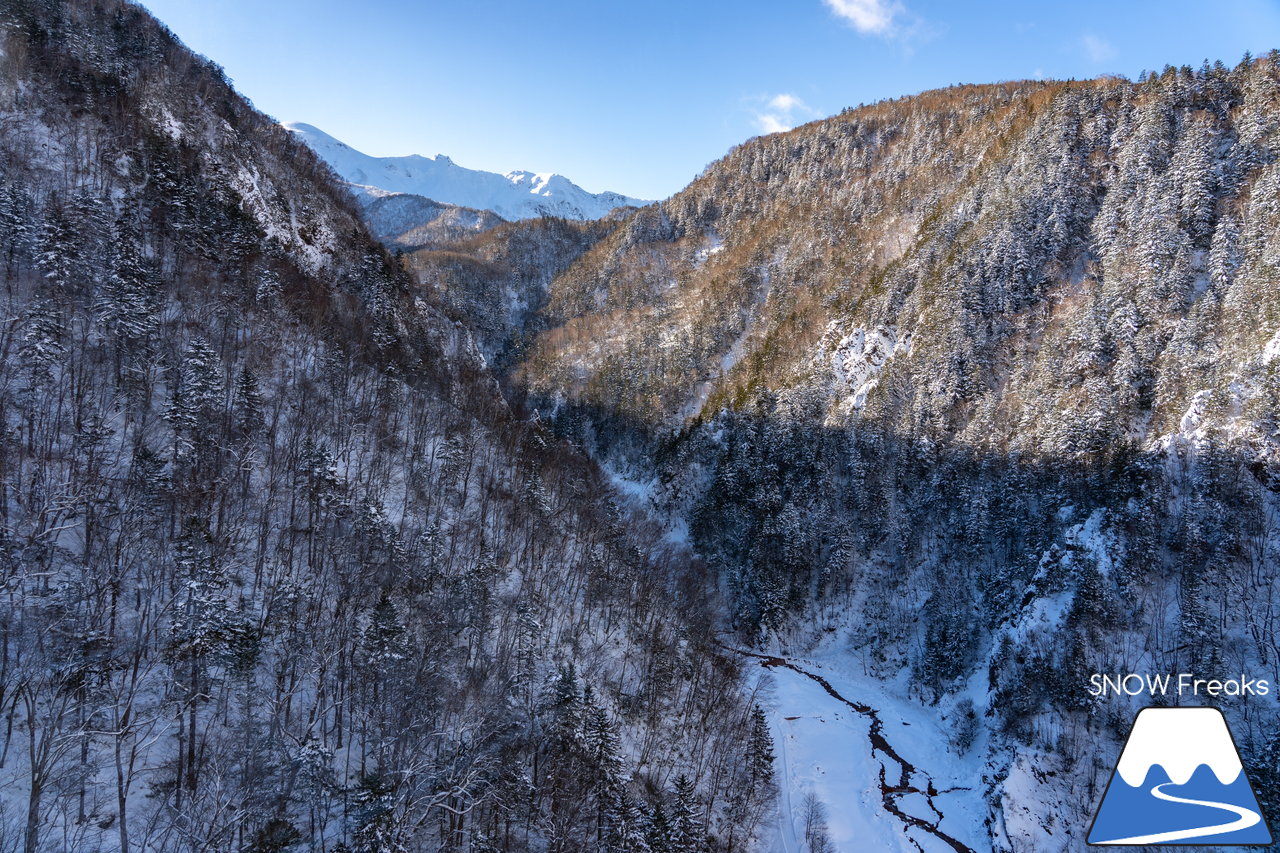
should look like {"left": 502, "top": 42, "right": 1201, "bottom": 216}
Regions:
{"left": 759, "top": 643, "right": 989, "bottom": 853}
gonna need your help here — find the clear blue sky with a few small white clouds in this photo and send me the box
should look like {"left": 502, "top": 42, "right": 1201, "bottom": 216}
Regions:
{"left": 143, "top": 0, "right": 1280, "bottom": 199}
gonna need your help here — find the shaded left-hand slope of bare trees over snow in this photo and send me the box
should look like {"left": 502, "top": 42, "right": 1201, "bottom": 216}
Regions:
{"left": 0, "top": 0, "right": 772, "bottom": 853}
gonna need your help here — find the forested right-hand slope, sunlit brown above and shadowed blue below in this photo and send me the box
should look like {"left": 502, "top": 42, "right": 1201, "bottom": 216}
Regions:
{"left": 424, "top": 54, "right": 1280, "bottom": 850}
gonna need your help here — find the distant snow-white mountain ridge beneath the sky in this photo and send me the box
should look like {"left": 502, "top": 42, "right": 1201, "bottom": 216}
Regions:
{"left": 284, "top": 122, "right": 649, "bottom": 220}
